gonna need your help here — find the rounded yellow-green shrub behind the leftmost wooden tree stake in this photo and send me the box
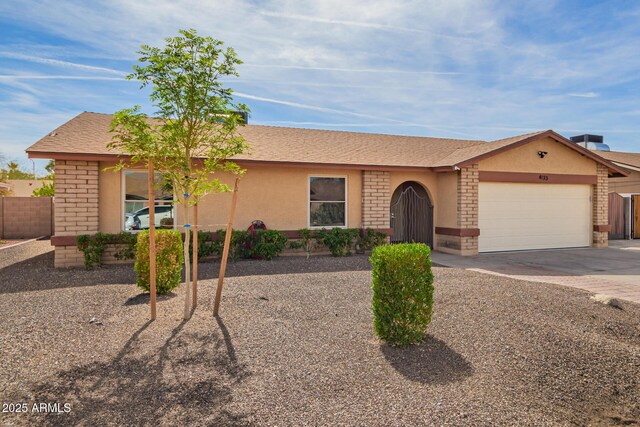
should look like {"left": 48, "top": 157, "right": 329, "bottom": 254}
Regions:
{"left": 134, "top": 230, "right": 184, "bottom": 294}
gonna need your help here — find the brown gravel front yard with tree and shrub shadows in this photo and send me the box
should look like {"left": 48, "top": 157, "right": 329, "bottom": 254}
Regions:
{"left": 0, "top": 249, "right": 640, "bottom": 426}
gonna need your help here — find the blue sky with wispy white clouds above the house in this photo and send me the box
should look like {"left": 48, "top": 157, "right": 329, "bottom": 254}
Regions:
{"left": 0, "top": 0, "right": 640, "bottom": 174}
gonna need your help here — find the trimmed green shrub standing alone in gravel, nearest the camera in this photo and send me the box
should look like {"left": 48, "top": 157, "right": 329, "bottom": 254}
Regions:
{"left": 370, "top": 243, "right": 433, "bottom": 345}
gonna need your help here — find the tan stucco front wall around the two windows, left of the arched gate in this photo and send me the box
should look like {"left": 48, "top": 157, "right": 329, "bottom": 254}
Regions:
{"left": 100, "top": 162, "right": 362, "bottom": 233}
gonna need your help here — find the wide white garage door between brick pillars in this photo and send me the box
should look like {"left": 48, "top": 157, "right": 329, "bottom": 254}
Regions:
{"left": 478, "top": 182, "right": 592, "bottom": 252}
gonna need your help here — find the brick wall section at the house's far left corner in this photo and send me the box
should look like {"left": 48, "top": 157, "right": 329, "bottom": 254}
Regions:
{"left": 55, "top": 160, "right": 99, "bottom": 267}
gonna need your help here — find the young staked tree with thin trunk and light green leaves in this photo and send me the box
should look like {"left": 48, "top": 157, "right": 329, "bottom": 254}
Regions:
{"left": 110, "top": 29, "right": 249, "bottom": 319}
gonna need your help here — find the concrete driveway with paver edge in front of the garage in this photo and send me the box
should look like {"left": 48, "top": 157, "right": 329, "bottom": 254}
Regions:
{"left": 433, "top": 240, "right": 640, "bottom": 303}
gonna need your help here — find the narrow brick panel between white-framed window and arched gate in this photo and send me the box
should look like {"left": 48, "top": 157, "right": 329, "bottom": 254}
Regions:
{"left": 362, "top": 171, "right": 391, "bottom": 228}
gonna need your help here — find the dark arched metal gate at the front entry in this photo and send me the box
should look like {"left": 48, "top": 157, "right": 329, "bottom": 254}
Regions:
{"left": 391, "top": 181, "right": 433, "bottom": 247}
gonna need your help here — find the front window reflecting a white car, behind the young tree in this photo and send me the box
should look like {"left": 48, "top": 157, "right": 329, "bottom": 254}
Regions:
{"left": 124, "top": 171, "right": 175, "bottom": 231}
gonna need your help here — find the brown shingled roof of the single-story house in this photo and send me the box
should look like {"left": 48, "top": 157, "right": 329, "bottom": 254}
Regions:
{"left": 27, "top": 112, "right": 621, "bottom": 173}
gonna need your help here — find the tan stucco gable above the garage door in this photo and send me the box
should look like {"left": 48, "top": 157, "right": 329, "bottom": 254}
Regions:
{"left": 478, "top": 138, "right": 597, "bottom": 175}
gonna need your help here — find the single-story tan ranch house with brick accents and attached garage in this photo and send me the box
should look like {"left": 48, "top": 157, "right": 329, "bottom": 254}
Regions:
{"left": 27, "top": 113, "right": 627, "bottom": 266}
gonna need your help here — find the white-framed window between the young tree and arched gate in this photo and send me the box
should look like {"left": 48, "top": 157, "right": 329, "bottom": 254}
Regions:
{"left": 309, "top": 176, "right": 347, "bottom": 227}
